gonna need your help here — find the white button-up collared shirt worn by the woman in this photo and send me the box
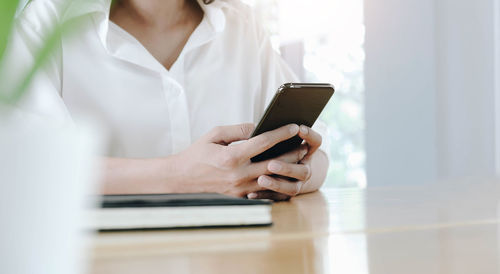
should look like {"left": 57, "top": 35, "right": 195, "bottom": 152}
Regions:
{"left": 4, "top": 0, "right": 296, "bottom": 157}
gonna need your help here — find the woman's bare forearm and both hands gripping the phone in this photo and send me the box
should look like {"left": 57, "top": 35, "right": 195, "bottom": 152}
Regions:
{"left": 101, "top": 124, "right": 328, "bottom": 200}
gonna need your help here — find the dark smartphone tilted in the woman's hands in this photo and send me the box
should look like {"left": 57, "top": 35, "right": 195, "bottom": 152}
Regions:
{"left": 251, "top": 83, "right": 335, "bottom": 162}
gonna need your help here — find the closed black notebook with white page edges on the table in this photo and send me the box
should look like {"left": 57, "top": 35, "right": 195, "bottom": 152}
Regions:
{"left": 90, "top": 193, "right": 272, "bottom": 231}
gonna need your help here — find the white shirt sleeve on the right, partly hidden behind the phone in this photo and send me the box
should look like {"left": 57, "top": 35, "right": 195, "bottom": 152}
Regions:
{"left": 255, "top": 23, "right": 330, "bottom": 152}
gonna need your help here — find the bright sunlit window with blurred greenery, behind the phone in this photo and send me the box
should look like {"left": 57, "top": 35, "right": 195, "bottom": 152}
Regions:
{"left": 245, "top": 0, "right": 366, "bottom": 187}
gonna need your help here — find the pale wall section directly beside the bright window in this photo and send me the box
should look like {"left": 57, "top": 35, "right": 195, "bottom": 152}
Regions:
{"left": 365, "top": 0, "right": 437, "bottom": 186}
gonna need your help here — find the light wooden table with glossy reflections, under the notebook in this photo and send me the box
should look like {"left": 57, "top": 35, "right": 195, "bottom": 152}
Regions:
{"left": 91, "top": 180, "right": 500, "bottom": 274}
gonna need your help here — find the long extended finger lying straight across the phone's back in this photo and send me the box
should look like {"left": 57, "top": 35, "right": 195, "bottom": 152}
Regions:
{"left": 233, "top": 124, "right": 299, "bottom": 159}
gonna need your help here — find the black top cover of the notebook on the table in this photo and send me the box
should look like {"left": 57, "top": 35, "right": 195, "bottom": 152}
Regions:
{"left": 101, "top": 193, "right": 271, "bottom": 208}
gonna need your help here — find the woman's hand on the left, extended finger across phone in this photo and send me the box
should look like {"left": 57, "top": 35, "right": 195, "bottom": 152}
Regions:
{"left": 169, "top": 124, "right": 299, "bottom": 197}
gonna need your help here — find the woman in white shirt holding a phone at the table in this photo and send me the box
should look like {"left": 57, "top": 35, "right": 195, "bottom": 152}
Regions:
{"left": 9, "top": 0, "right": 328, "bottom": 200}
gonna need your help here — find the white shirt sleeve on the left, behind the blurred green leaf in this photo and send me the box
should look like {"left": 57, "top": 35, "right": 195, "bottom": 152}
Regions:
{"left": 0, "top": 0, "right": 71, "bottom": 123}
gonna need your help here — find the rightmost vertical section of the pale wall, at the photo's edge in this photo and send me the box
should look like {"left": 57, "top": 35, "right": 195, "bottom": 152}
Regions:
{"left": 436, "top": 0, "right": 495, "bottom": 178}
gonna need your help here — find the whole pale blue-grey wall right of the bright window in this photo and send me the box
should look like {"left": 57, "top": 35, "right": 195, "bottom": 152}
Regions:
{"left": 365, "top": 0, "right": 496, "bottom": 186}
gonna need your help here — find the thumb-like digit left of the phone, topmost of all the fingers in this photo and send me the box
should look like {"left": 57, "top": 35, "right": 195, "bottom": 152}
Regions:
{"left": 204, "top": 123, "right": 255, "bottom": 145}
